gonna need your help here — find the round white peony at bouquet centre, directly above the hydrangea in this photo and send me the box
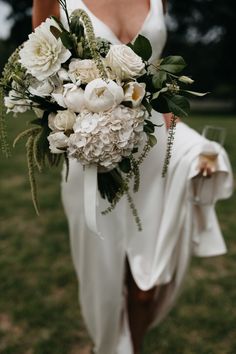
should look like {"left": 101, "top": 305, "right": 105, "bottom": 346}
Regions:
{"left": 84, "top": 79, "right": 124, "bottom": 112}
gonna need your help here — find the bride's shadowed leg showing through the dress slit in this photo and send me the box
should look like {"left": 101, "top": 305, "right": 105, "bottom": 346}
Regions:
{"left": 126, "top": 261, "right": 172, "bottom": 354}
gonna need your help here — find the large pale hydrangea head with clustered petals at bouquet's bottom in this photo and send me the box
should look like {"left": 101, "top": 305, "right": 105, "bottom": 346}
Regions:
{"left": 68, "top": 105, "right": 146, "bottom": 169}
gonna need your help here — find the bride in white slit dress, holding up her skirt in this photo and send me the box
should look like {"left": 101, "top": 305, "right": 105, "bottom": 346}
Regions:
{"left": 33, "top": 0, "right": 232, "bottom": 354}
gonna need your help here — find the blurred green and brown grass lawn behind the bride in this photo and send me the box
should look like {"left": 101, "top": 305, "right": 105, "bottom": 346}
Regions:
{"left": 0, "top": 112, "right": 236, "bottom": 354}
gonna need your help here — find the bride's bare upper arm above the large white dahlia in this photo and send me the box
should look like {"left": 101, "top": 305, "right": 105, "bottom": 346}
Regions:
{"left": 32, "top": 0, "right": 60, "bottom": 28}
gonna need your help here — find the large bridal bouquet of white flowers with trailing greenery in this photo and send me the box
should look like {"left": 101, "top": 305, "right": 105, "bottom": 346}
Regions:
{"left": 0, "top": 0, "right": 205, "bottom": 228}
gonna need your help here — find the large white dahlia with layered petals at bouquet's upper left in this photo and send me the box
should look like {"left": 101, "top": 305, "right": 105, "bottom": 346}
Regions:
{"left": 19, "top": 19, "right": 71, "bottom": 81}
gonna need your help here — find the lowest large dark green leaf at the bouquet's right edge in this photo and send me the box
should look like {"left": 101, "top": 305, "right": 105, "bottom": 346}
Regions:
{"left": 164, "top": 95, "right": 190, "bottom": 118}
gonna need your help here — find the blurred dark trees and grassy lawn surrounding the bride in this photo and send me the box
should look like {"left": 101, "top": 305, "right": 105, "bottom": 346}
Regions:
{"left": 0, "top": 0, "right": 236, "bottom": 354}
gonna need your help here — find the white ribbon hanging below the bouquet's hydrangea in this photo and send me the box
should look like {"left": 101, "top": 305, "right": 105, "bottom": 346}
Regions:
{"left": 84, "top": 165, "right": 101, "bottom": 236}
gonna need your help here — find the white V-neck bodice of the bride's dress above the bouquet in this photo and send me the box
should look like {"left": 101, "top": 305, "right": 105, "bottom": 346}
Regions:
{"left": 61, "top": 0, "right": 166, "bottom": 61}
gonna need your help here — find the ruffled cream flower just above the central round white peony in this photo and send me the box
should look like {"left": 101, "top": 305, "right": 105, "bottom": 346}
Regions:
{"left": 69, "top": 59, "right": 100, "bottom": 84}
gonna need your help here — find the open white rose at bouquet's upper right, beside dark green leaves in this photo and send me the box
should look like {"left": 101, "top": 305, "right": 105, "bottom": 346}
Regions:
{"left": 106, "top": 44, "right": 145, "bottom": 80}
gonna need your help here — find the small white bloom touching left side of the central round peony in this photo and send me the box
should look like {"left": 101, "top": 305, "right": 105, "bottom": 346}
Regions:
{"left": 63, "top": 84, "right": 85, "bottom": 113}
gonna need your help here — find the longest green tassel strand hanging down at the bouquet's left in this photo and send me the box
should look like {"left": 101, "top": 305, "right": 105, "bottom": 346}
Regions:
{"left": 26, "top": 135, "right": 39, "bottom": 215}
